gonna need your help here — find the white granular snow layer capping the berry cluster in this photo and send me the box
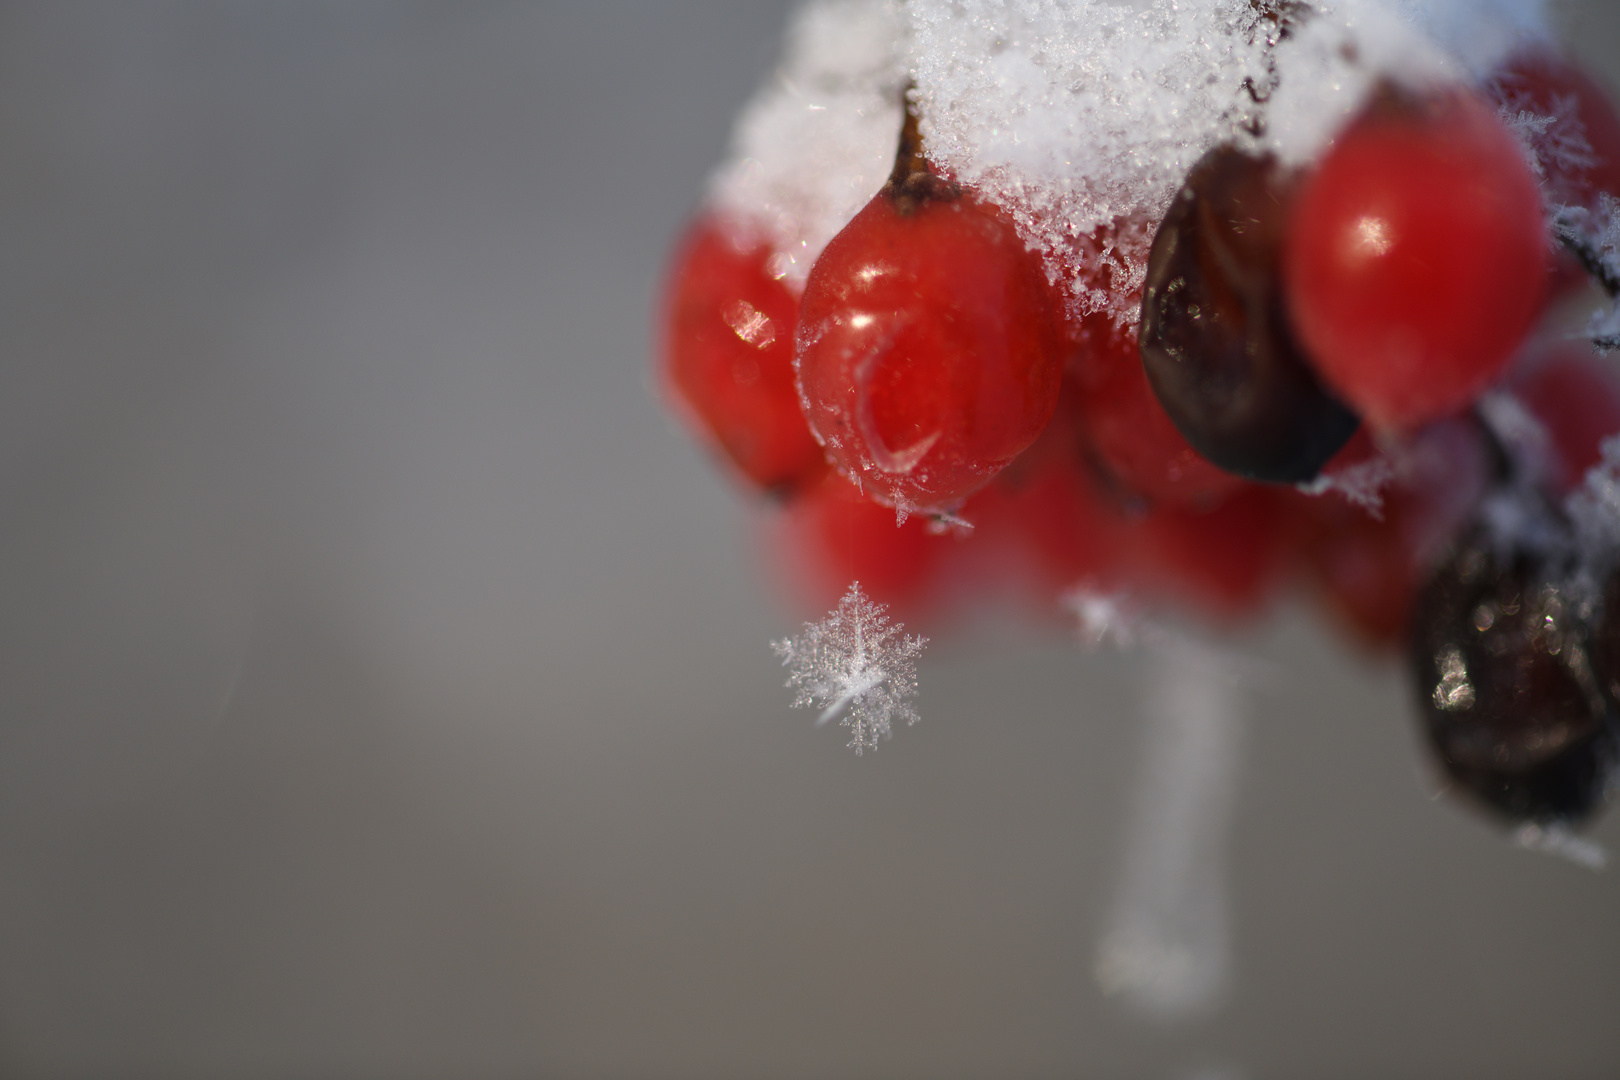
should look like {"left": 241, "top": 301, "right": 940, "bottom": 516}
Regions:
{"left": 711, "top": 0, "right": 1544, "bottom": 324}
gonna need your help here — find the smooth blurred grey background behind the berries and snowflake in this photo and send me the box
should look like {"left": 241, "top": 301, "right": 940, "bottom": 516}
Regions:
{"left": 0, "top": 0, "right": 1620, "bottom": 1080}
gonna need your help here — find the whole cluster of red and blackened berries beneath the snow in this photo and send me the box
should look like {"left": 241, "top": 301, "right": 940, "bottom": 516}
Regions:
{"left": 663, "top": 40, "right": 1620, "bottom": 824}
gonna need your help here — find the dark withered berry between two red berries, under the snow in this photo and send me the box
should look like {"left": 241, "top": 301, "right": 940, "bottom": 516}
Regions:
{"left": 1139, "top": 146, "right": 1358, "bottom": 483}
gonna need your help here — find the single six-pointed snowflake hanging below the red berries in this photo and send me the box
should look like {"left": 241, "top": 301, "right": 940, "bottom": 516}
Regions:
{"left": 771, "top": 581, "right": 928, "bottom": 755}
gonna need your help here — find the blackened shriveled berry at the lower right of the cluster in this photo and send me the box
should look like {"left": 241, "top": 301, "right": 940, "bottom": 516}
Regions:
{"left": 1411, "top": 529, "right": 1617, "bottom": 823}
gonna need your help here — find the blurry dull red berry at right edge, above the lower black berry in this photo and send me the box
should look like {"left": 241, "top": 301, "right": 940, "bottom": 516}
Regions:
{"left": 1511, "top": 345, "right": 1620, "bottom": 495}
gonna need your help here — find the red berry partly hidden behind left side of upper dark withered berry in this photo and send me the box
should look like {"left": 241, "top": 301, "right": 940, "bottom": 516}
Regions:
{"left": 1072, "top": 321, "right": 1243, "bottom": 507}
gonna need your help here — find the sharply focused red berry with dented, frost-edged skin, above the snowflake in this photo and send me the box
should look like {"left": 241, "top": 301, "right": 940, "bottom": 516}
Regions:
{"left": 797, "top": 191, "right": 1063, "bottom": 510}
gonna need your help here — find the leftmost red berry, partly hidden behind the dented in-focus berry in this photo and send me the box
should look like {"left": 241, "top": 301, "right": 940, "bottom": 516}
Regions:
{"left": 661, "top": 217, "right": 826, "bottom": 495}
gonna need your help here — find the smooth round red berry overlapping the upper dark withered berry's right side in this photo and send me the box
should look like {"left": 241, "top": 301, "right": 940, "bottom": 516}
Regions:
{"left": 1283, "top": 91, "right": 1547, "bottom": 429}
